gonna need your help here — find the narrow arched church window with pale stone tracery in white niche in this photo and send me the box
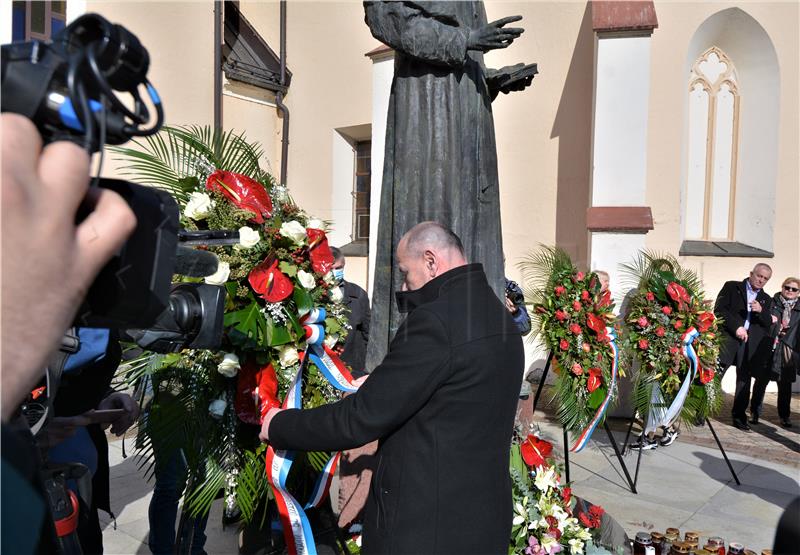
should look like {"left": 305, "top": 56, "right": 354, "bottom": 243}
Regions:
{"left": 686, "top": 46, "right": 739, "bottom": 241}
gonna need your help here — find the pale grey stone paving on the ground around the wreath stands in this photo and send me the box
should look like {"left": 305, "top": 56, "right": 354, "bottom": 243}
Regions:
{"left": 101, "top": 392, "right": 800, "bottom": 555}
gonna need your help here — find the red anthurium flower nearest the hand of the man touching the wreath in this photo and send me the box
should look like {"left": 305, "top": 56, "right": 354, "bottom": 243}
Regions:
{"left": 234, "top": 360, "right": 281, "bottom": 426}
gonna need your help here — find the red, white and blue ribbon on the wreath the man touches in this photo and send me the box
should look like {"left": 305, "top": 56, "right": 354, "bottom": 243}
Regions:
{"left": 266, "top": 308, "right": 358, "bottom": 555}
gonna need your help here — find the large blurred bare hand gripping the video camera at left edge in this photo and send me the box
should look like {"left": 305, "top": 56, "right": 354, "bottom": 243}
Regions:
{"left": 0, "top": 113, "right": 136, "bottom": 419}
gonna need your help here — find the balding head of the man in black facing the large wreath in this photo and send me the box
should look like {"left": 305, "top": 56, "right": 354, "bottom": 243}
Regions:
{"left": 397, "top": 222, "right": 467, "bottom": 291}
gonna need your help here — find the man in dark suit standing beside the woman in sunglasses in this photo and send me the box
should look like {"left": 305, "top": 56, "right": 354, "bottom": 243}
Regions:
{"left": 714, "top": 262, "right": 772, "bottom": 432}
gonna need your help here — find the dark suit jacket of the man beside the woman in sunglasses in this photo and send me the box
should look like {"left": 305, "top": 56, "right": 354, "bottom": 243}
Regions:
{"left": 714, "top": 280, "right": 772, "bottom": 375}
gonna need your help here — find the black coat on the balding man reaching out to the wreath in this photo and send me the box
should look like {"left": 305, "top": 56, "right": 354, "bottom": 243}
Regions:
{"left": 269, "top": 264, "right": 524, "bottom": 555}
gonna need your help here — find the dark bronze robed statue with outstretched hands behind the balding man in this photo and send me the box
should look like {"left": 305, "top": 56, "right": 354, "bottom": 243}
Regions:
{"left": 364, "top": 1, "right": 536, "bottom": 371}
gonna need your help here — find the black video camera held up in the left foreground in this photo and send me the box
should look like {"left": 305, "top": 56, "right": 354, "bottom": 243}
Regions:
{"left": 0, "top": 14, "right": 225, "bottom": 352}
